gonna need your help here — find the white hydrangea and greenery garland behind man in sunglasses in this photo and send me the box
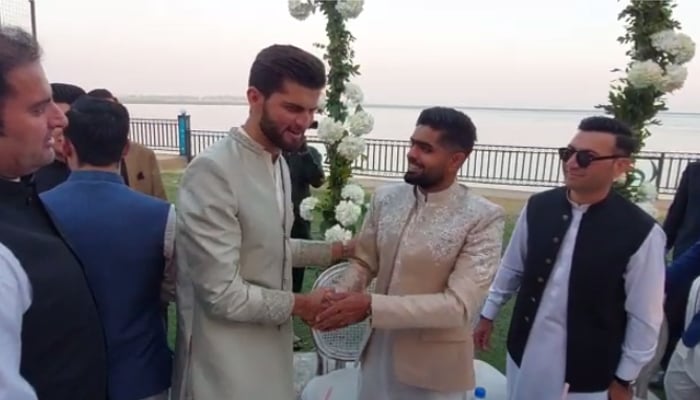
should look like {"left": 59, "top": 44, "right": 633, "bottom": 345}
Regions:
{"left": 597, "top": 0, "right": 695, "bottom": 216}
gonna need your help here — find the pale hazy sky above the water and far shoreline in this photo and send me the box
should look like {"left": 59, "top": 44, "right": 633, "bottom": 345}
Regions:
{"left": 6, "top": 0, "right": 700, "bottom": 112}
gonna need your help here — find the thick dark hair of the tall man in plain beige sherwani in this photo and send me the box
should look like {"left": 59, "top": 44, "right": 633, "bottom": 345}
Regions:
{"left": 248, "top": 44, "right": 326, "bottom": 97}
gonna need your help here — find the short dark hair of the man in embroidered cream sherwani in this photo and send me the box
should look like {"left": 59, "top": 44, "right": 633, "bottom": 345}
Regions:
{"left": 416, "top": 107, "right": 476, "bottom": 153}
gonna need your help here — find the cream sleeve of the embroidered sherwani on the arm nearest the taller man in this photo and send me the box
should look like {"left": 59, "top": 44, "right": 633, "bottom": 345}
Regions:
{"left": 336, "top": 192, "right": 379, "bottom": 292}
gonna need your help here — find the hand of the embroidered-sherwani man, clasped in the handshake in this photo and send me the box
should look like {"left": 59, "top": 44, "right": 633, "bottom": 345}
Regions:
{"left": 313, "top": 292, "right": 372, "bottom": 331}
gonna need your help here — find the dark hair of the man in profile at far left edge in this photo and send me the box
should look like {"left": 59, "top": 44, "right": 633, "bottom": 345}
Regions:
{"left": 0, "top": 26, "right": 41, "bottom": 135}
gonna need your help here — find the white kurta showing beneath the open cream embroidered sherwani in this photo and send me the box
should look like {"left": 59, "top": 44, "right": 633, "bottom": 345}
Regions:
{"left": 358, "top": 196, "right": 468, "bottom": 400}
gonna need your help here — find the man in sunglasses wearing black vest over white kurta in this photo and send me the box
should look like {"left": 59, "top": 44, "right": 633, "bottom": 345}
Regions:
{"left": 474, "top": 117, "right": 666, "bottom": 400}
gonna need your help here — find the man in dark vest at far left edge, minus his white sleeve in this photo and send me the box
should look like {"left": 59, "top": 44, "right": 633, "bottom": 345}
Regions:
{"left": 0, "top": 27, "right": 107, "bottom": 400}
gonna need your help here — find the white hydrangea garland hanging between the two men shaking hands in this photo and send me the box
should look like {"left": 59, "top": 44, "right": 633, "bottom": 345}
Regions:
{"left": 289, "top": 0, "right": 374, "bottom": 241}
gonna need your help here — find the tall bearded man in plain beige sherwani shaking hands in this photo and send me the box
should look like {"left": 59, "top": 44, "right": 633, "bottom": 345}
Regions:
{"left": 173, "top": 45, "right": 348, "bottom": 400}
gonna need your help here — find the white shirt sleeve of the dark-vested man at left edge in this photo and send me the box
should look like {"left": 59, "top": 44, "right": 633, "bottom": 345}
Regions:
{"left": 0, "top": 244, "right": 37, "bottom": 400}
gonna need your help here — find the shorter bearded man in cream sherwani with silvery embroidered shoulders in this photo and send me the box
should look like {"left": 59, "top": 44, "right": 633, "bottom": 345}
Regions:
{"left": 315, "top": 107, "right": 504, "bottom": 400}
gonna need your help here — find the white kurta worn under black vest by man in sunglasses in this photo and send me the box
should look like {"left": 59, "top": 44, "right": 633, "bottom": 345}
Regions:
{"left": 482, "top": 198, "right": 666, "bottom": 400}
